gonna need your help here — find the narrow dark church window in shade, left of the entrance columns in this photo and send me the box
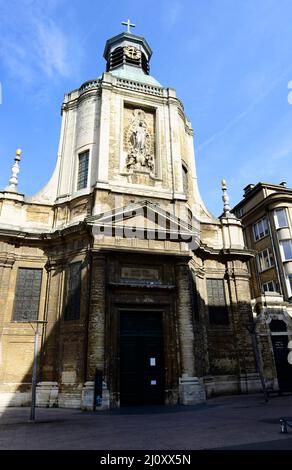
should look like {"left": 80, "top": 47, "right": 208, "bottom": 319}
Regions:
{"left": 64, "top": 261, "right": 82, "bottom": 321}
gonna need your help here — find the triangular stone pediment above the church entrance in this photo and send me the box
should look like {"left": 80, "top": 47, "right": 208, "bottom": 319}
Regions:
{"left": 87, "top": 201, "right": 198, "bottom": 241}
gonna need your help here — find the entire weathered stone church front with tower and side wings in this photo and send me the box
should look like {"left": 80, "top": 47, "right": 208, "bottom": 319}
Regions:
{"left": 0, "top": 27, "right": 260, "bottom": 409}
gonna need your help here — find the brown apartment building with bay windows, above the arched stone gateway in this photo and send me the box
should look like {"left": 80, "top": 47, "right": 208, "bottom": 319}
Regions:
{"left": 233, "top": 182, "right": 292, "bottom": 302}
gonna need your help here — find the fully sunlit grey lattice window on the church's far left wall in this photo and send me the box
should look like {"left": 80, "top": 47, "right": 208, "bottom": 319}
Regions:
{"left": 13, "top": 268, "right": 42, "bottom": 322}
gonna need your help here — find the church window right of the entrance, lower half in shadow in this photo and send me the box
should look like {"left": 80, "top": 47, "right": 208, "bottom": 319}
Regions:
{"left": 207, "top": 279, "right": 229, "bottom": 325}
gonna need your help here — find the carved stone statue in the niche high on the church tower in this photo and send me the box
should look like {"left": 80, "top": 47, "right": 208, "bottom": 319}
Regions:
{"left": 126, "top": 109, "right": 154, "bottom": 172}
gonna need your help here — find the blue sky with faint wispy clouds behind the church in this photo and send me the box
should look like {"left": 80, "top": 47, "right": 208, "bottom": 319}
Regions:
{"left": 0, "top": 0, "right": 292, "bottom": 215}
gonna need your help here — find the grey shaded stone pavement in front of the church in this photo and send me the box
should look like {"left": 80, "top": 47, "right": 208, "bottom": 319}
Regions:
{"left": 0, "top": 394, "right": 292, "bottom": 450}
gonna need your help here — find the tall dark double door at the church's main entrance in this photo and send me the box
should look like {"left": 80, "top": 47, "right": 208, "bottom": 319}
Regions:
{"left": 120, "top": 310, "right": 165, "bottom": 406}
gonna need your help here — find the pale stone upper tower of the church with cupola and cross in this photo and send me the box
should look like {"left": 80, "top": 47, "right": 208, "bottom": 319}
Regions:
{"left": 23, "top": 20, "right": 203, "bottom": 225}
